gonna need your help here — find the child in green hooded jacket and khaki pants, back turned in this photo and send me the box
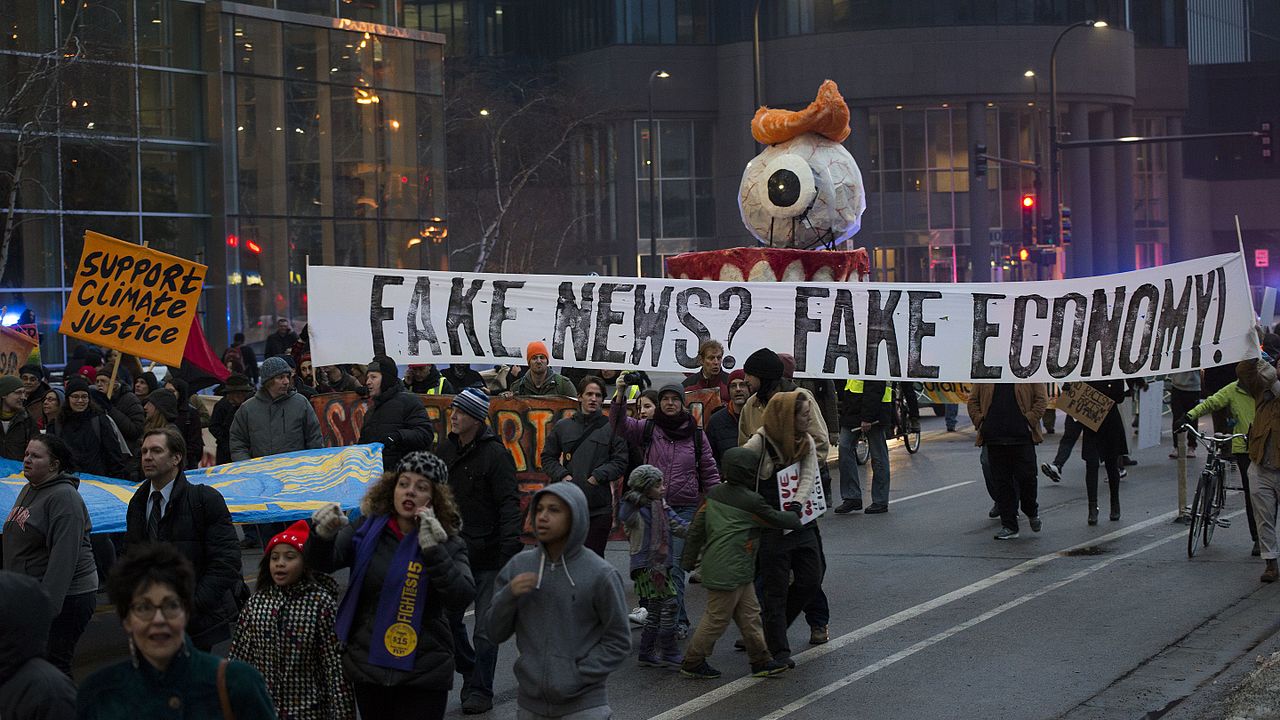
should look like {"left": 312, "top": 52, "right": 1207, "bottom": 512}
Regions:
{"left": 680, "top": 447, "right": 800, "bottom": 680}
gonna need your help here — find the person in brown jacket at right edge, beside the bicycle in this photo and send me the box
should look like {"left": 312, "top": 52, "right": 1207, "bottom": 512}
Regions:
{"left": 1235, "top": 332, "right": 1280, "bottom": 583}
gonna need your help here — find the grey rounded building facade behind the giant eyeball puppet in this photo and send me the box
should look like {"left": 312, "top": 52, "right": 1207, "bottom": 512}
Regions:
{"left": 413, "top": 0, "right": 1280, "bottom": 282}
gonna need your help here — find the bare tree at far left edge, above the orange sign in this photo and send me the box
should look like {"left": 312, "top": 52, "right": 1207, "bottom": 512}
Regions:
{"left": 0, "top": 3, "right": 86, "bottom": 283}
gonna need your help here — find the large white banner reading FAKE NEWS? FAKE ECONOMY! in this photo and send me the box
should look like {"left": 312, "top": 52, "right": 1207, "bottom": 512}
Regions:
{"left": 307, "top": 254, "right": 1258, "bottom": 382}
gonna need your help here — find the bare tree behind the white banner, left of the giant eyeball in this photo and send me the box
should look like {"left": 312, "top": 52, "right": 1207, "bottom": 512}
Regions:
{"left": 445, "top": 59, "right": 604, "bottom": 272}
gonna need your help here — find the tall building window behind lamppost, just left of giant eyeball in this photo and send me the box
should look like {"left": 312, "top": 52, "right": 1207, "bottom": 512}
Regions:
{"left": 635, "top": 120, "right": 716, "bottom": 252}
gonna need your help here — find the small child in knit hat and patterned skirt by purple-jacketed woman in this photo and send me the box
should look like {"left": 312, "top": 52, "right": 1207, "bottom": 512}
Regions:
{"left": 618, "top": 465, "right": 687, "bottom": 667}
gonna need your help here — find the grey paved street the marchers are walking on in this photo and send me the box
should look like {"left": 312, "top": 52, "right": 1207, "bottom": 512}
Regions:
{"left": 70, "top": 411, "right": 1280, "bottom": 720}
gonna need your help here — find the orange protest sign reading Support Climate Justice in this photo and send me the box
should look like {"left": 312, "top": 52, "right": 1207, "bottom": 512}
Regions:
{"left": 59, "top": 231, "right": 207, "bottom": 365}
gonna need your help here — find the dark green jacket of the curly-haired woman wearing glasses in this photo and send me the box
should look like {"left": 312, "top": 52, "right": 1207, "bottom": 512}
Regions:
{"left": 76, "top": 638, "right": 275, "bottom": 720}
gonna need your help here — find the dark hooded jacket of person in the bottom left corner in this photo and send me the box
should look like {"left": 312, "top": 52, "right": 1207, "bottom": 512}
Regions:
{"left": 0, "top": 570, "right": 76, "bottom": 720}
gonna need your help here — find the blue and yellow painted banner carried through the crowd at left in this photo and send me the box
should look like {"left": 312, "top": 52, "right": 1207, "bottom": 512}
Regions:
{"left": 0, "top": 443, "right": 383, "bottom": 533}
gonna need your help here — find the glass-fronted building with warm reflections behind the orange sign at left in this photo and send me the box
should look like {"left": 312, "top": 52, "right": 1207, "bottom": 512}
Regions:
{"left": 0, "top": 0, "right": 445, "bottom": 363}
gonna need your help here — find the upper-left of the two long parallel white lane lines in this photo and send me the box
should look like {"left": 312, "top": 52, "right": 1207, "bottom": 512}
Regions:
{"left": 650, "top": 512, "right": 1185, "bottom": 720}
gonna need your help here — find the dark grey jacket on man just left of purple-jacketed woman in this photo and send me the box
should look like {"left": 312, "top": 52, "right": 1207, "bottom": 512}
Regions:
{"left": 541, "top": 411, "right": 627, "bottom": 518}
